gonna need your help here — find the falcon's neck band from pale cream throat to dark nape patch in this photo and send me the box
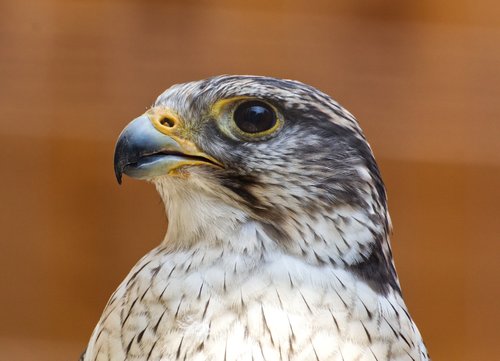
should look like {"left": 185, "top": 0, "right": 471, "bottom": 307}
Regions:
{"left": 152, "top": 176, "right": 399, "bottom": 289}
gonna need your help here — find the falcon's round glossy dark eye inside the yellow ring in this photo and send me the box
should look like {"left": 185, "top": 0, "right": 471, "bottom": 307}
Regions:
{"left": 233, "top": 100, "right": 277, "bottom": 133}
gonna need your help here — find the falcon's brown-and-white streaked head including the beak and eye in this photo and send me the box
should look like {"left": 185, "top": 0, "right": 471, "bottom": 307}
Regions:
{"left": 115, "top": 76, "right": 398, "bottom": 292}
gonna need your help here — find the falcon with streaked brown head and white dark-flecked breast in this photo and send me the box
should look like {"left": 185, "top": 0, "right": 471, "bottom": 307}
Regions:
{"left": 82, "top": 75, "right": 429, "bottom": 361}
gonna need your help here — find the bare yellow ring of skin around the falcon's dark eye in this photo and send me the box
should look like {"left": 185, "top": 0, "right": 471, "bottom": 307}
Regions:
{"left": 210, "top": 96, "right": 283, "bottom": 141}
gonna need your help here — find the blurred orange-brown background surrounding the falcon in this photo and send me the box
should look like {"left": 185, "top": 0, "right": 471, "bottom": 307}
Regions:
{"left": 0, "top": 0, "right": 500, "bottom": 361}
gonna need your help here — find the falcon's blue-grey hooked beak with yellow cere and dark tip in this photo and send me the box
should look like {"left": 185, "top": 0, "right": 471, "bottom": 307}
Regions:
{"left": 114, "top": 110, "right": 223, "bottom": 184}
